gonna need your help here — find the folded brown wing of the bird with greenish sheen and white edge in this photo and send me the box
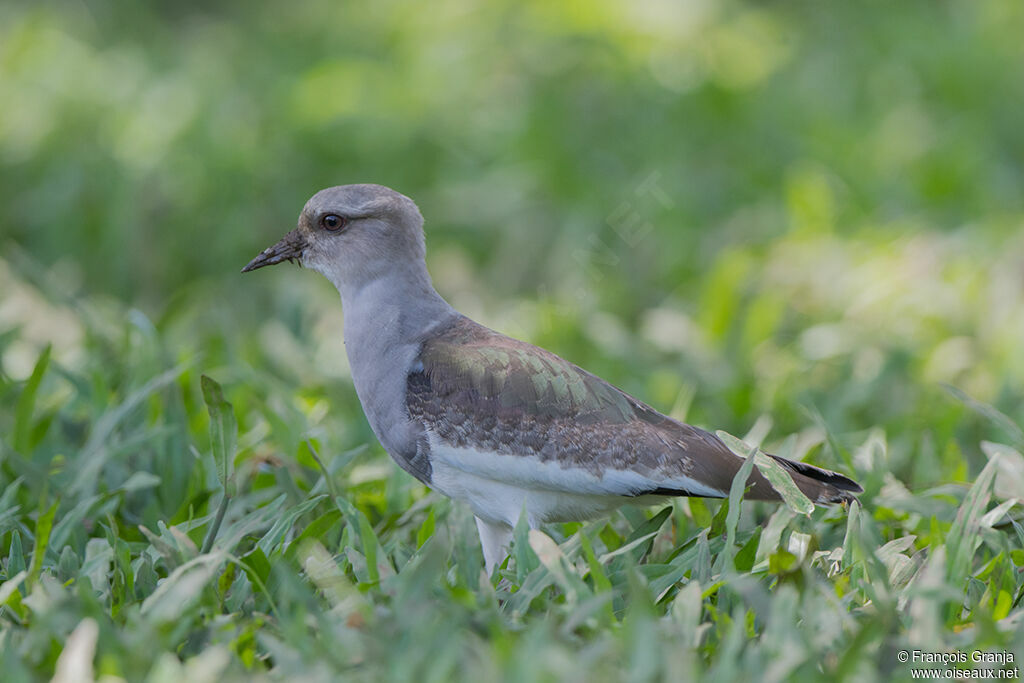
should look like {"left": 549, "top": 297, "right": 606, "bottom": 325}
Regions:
{"left": 407, "top": 316, "right": 856, "bottom": 500}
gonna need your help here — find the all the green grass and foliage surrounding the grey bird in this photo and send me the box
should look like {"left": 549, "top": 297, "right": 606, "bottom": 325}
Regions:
{"left": 0, "top": 0, "right": 1024, "bottom": 680}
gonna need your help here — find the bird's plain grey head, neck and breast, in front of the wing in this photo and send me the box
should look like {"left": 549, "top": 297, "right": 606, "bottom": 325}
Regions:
{"left": 242, "top": 184, "right": 457, "bottom": 479}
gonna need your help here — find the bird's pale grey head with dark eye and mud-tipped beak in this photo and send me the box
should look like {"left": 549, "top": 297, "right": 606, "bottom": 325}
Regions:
{"left": 242, "top": 184, "right": 426, "bottom": 289}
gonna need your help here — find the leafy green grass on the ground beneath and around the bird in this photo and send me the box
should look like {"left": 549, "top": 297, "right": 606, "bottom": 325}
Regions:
{"left": 0, "top": 242, "right": 1024, "bottom": 681}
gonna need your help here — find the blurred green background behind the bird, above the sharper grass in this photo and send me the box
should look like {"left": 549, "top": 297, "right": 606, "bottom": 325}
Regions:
{"left": 0, "top": 0, "right": 1024, "bottom": 475}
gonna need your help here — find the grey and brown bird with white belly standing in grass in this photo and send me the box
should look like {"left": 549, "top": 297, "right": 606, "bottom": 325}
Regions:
{"left": 242, "top": 183, "right": 862, "bottom": 577}
